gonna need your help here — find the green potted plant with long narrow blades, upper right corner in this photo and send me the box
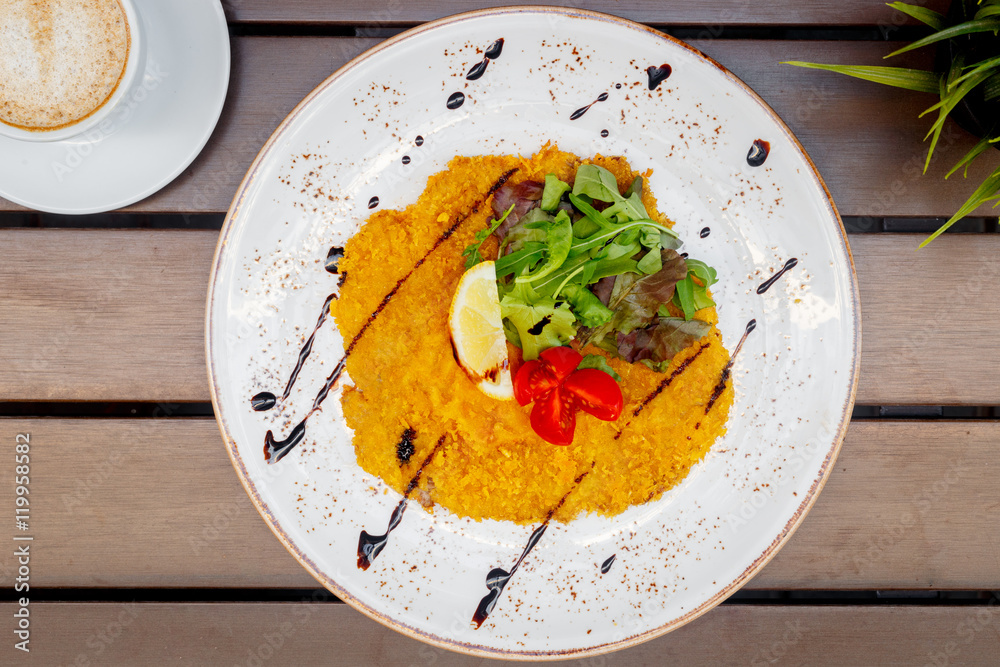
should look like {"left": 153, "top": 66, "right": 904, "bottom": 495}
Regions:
{"left": 783, "top": 0, "right": 1000, "bottom": 248}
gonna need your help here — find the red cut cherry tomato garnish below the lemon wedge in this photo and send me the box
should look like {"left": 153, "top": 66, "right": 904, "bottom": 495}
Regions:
{"left": 514, "top": 347, "right": 623, "bottom": 445}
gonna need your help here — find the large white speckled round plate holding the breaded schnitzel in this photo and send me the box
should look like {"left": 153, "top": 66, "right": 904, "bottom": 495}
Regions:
{"left": 207, "top": 7, "right": 860, "bottom": 659}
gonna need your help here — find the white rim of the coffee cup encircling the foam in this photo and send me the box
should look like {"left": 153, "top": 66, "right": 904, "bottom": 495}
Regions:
{"left": 0, "top": 0, "right": 142, "bottom": 141}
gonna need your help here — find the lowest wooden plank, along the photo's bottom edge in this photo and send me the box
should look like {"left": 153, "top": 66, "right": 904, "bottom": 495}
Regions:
{"left": 0, "top": 600, "right": 1000, "bottom": 667}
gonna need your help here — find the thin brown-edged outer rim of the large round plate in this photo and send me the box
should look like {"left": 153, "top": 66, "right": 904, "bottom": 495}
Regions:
{"left": 205, "top": 5, "right": 862, "bottom": 661}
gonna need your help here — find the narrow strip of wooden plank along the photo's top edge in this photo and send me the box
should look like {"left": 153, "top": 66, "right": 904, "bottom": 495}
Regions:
{"left": 223, "top": 0, "right": 948, "bottom": 27}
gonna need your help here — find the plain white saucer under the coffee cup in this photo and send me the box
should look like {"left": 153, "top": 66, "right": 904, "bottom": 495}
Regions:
{"left": 0, "top": 0, "right": 229, "bottom": 214}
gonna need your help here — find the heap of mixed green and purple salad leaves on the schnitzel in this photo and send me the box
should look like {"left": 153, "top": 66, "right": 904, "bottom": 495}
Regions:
{"left": 463, "top": 159, "right": 717, "bottom": 372}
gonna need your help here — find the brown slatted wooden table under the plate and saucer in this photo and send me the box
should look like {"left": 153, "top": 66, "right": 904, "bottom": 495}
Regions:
{"left": 0, "top": 0, "right": 1000, "bottom": 665}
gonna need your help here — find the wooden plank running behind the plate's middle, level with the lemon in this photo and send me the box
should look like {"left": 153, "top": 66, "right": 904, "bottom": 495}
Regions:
{"left": 0, "top": 229, "right": 1000, "bottom": 405}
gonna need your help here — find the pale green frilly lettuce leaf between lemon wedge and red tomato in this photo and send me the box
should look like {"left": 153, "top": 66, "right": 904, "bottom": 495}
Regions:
{"left": 500, "top": 283, "right": 576, "bottom": 361}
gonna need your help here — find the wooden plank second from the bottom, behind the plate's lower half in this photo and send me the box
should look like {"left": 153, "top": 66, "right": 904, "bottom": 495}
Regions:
{"left": 0, "top": 419, "right": 1000, "bottom": 590}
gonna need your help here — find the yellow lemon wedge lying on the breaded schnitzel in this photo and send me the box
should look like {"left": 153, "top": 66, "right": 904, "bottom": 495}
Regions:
{"left": 448, "top": 262, "right": 514, "bottom": 400}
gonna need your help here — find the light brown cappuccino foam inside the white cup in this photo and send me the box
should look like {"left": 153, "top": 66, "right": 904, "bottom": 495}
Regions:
{"left": 0, "top": 0, "right": 131, "bottom": 130}
